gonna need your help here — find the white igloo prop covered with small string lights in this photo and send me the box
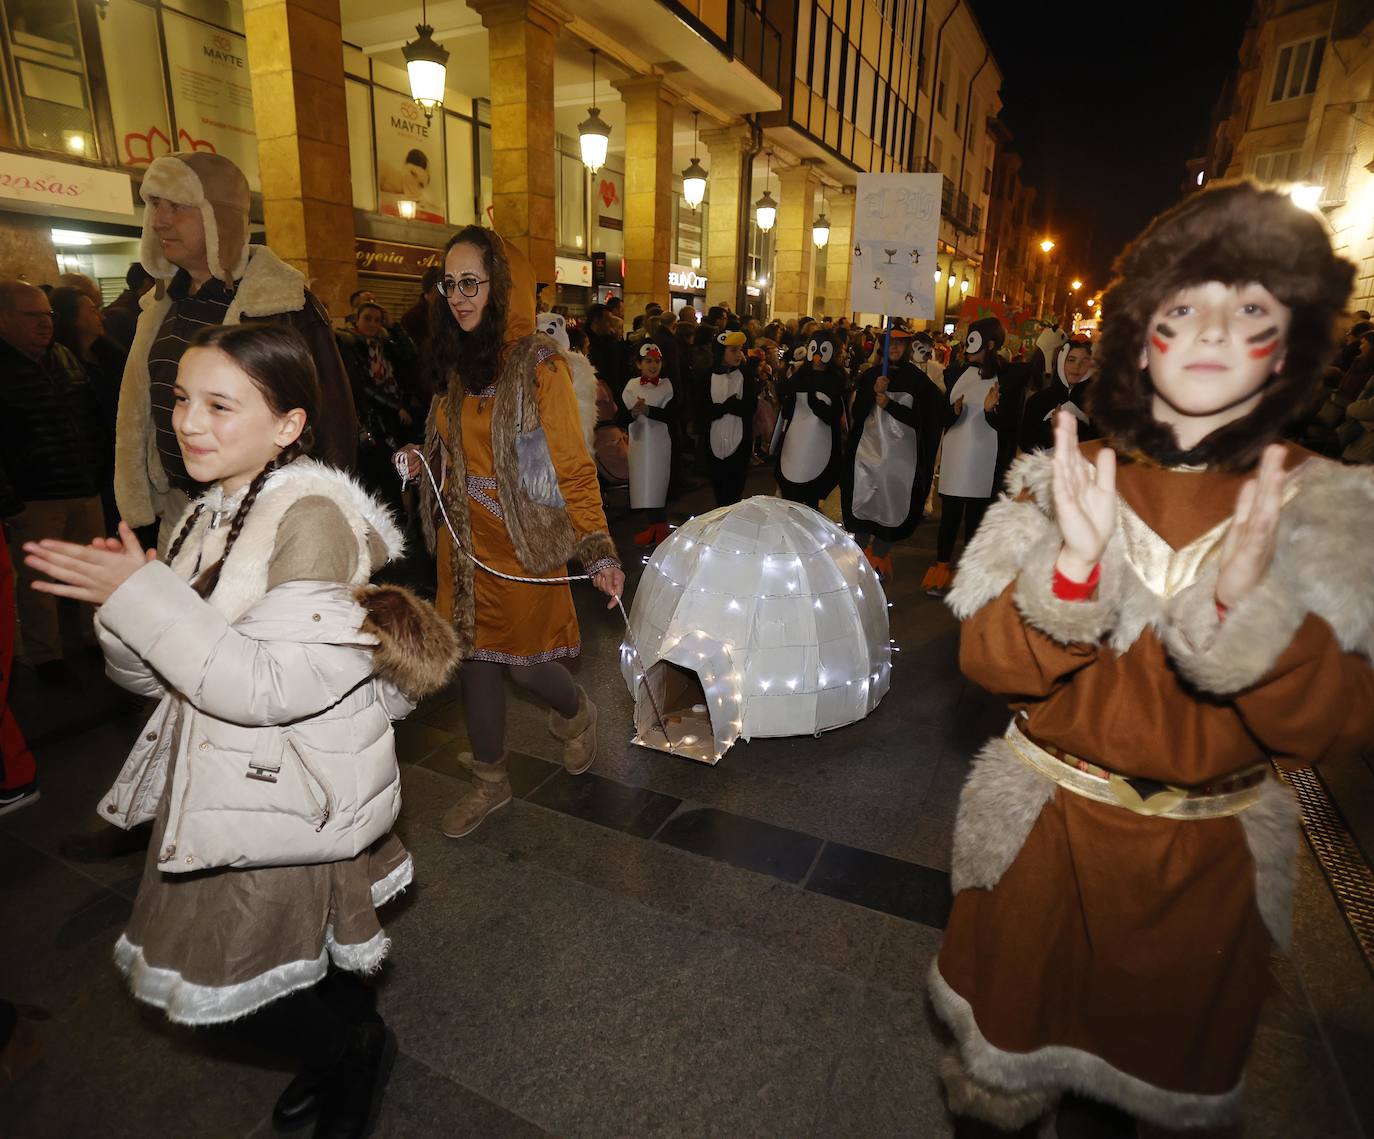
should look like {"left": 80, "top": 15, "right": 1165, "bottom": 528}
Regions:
{"left": 621, "top": 496, "right": 892, "bottom": 764}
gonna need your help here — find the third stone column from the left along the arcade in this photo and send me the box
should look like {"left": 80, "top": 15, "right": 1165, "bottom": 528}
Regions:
{"left": 611, "top": 76, "right": 673, "bottom": 319}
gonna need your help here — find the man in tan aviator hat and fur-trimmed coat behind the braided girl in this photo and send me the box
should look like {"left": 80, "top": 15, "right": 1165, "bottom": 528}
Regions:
{"left": 114, "top": 151, "right": 357, "bottom": 545}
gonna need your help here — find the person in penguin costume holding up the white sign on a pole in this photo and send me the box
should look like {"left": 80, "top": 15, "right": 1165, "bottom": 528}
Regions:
{"left": 840, "top": 320, "right": 945, "bottom": 580}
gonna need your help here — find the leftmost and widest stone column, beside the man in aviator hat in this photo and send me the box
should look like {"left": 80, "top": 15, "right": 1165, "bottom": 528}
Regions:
{"left": 243, "top": 0, "right": 357, "bottom": 315}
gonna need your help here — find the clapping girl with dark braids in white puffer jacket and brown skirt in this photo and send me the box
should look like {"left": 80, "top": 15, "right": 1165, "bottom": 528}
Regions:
{"left": 26, "top": 323, "right": 456, "bottom": 1139}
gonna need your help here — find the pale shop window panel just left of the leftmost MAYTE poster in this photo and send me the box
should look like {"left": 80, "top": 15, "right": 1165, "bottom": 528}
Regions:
{"left": 98, "top": 0, "right": 176, "bottom": 166}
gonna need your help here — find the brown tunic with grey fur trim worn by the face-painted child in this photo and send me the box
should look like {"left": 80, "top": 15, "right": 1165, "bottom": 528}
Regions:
{"left": 929, "top": 444, "right": 1374, "bottom": 1128}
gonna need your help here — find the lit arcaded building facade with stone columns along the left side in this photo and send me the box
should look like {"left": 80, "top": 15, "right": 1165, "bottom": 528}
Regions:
{"left": 0, "top": 0, "right": 1033, "bottom": 320}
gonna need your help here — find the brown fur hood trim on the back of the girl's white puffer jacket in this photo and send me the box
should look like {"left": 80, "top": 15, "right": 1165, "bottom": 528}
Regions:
{"left": 353, "top": 585, "right": 459, "bottom": 699}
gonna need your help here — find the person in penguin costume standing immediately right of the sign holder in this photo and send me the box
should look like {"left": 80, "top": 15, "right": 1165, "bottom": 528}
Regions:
{"left": 922, "top": 316, "right": 1037, "bottom": 596}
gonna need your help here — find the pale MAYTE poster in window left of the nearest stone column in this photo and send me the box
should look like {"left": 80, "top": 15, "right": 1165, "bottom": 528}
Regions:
{"left": 162, "top": 11, "right": 262, "bottom": 190}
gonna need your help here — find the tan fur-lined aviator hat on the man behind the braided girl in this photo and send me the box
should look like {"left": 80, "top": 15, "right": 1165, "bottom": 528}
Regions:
{"left": 139, "top": 151, "right": 249, "bottom": 295}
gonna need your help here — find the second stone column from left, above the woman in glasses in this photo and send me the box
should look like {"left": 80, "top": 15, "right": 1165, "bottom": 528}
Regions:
{"left": 464, "top": 0, "right": 570, "bottom": 283}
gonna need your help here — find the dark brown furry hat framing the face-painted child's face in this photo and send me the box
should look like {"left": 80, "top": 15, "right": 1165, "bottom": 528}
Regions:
{"left": 1090, "top": 183, "right": 1355, "bottom": 470}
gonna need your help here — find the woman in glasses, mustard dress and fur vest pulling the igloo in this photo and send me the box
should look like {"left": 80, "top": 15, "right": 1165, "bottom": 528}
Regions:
{"left": 409, "top": 225, "right": 625, "bottom": 838}
